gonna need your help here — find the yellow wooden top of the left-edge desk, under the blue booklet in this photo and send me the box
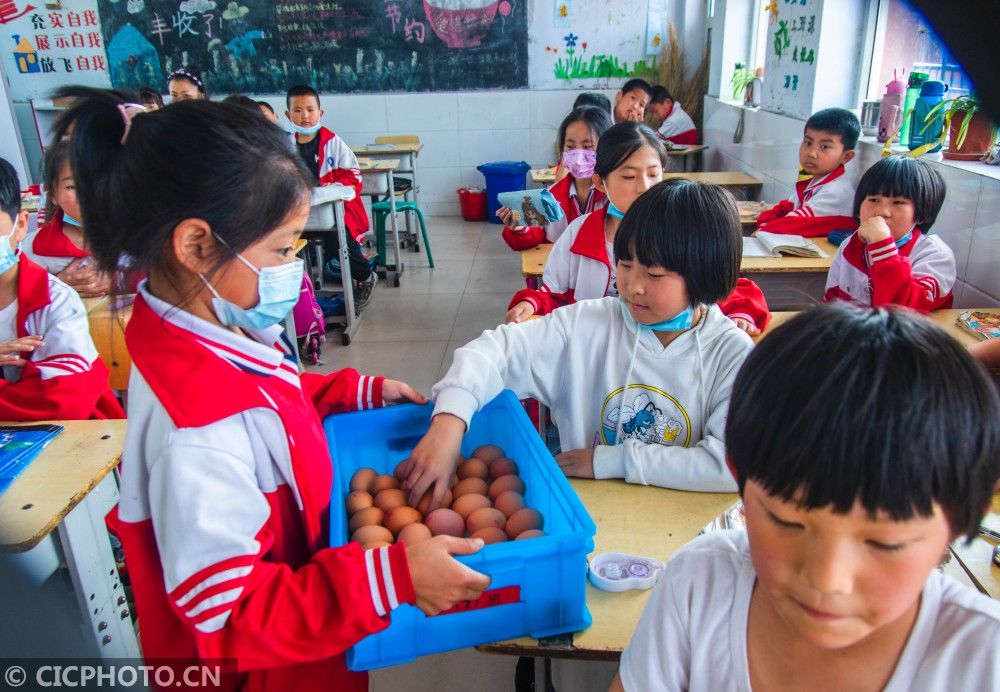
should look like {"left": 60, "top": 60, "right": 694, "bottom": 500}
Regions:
{"left": 0, "top": 420, "right": 125, "bottom": 553}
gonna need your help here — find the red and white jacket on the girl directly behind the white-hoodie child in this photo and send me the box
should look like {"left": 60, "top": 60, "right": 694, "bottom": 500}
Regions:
{"left": 507, "top": 208, "right": 771, "bottom": 329}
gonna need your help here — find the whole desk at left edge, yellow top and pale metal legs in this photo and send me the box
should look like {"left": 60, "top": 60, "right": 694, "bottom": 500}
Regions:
{"left": 0, "top": 420, "right": 139, "bottom": 658}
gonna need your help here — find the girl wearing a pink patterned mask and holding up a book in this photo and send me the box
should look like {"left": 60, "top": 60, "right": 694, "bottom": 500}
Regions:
{"left": 497, "top": 106, "right": 611, "bottom": 251}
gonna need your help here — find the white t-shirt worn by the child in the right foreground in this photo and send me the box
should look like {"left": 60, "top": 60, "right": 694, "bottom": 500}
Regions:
{"left": 620, "top": 530, "right": 1000, "bottom": 692}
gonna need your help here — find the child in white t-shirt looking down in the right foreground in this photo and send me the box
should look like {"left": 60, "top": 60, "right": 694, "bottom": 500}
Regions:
{"left": 611, "top": 306, "right": 1000, "bottom": 692}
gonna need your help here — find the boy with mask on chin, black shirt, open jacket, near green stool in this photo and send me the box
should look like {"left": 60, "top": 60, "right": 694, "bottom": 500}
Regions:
{"left": 285, "top": 84, "right": 376, "bottom": 309}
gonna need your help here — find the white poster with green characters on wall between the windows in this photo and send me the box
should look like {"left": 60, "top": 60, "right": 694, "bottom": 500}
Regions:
{"left": 761, "top": 0, "right": 823, "bottom": 120}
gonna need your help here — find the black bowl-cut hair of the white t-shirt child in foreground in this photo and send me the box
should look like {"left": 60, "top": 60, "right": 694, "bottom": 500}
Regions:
{"left": 726, "top": 303, "right": 1000, "bottom": 538}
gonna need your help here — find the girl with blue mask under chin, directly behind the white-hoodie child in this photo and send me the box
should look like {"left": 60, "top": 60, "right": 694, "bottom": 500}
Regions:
{"left": 507, "top": 121, "right": 771, "bottom": 335}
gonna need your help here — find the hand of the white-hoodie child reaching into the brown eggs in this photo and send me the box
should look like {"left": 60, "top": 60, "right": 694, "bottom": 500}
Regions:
{"left": 402, "top": 413, "right": 465, "bottom": 511}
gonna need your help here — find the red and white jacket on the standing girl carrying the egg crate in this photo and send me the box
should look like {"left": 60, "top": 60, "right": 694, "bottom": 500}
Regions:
{"left": 112, "top": 284, "right": 416, "bottom": 692}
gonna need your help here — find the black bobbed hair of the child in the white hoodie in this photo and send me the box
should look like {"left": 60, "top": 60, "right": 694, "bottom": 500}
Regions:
{"left": 615, "top": 180, "right": 743, "bottom": 305}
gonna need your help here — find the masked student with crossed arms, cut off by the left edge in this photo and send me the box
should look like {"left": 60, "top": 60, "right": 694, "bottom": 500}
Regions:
{"left": 0, "top": 159, "right": 125, "bottom": 421}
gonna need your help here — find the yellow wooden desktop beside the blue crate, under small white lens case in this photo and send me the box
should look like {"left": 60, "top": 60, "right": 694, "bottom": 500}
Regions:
{"left": 477, "top": 478, "right": 738, "bottom": 661}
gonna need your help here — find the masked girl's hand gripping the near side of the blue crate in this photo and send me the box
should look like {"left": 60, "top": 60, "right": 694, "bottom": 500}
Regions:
{"left": 406, "top": 536, "right": 490, "bottom": 615}
